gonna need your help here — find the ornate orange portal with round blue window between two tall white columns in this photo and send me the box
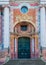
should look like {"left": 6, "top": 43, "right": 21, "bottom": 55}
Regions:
{"left": 10, "top": 3, "right": 39, "bottom": 59}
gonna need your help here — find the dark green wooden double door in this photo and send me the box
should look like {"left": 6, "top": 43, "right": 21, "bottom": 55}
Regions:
{"left": 18, "top": 37, "right": 30, "bottom": 58}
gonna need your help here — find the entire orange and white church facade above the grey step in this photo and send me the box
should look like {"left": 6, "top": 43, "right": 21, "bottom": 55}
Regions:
{"left": 0, "top": 0, "right": 46, "bottom": 59}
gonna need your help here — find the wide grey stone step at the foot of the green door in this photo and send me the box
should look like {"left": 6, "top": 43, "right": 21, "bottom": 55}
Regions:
{"left": 4, "top": 59, "right": 45, "bottom": 65}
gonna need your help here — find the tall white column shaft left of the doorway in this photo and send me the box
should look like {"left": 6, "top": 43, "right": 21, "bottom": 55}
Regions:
{"left": 3, "top": 7, "right": 10, "bottom": 48}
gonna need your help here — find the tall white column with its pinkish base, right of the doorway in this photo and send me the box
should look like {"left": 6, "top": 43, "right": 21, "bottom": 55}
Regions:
{"left": 40, "top": 7, "right": 46, "bottom": 59}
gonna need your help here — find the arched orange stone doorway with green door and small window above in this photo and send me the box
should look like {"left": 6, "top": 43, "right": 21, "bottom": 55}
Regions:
{"left": 10, "top": 21, "right": 39, "bottom": 58}
